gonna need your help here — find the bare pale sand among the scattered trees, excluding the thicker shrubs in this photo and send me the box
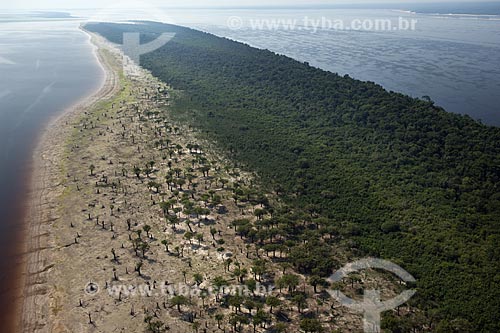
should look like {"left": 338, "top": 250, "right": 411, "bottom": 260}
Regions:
{"left": 18, "top": 36, "right": 274, "bottom": 333}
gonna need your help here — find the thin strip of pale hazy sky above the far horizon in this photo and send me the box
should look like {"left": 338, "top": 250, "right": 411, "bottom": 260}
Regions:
{"left": 0, "top": 0, "right": 500, "bottom": 9}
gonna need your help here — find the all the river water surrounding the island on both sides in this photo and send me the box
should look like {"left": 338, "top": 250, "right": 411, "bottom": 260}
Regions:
{"left": 0, "top": 7, "right": 500, "bottom": 332}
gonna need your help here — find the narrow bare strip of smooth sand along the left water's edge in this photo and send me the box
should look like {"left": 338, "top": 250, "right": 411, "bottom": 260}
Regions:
{"left": 19, "top": 27, "right": 119, "bottom": 332}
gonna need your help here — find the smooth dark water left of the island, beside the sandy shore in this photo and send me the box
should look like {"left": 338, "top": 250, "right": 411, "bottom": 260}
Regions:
{"left": 0, "top": 14, "right": 103, "bottom": 326}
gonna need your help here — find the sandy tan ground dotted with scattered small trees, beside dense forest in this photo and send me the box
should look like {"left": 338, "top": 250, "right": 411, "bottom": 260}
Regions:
{"left": 19, "top": 26, "right": 376, "bottom": 333}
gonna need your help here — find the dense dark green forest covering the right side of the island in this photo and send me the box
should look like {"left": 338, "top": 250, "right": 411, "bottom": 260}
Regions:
{"left": 86, "top": 23, "right": 500, "bottom": 332}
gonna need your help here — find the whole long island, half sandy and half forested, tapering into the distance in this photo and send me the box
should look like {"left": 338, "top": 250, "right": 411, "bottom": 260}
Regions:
{"left": 22, "top": 22, "right": 500, "bottom": 332}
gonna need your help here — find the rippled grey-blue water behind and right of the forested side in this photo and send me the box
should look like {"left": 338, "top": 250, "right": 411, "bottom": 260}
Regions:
{"left": 77, "top": 7, "right": 500, "bottom": 126}
